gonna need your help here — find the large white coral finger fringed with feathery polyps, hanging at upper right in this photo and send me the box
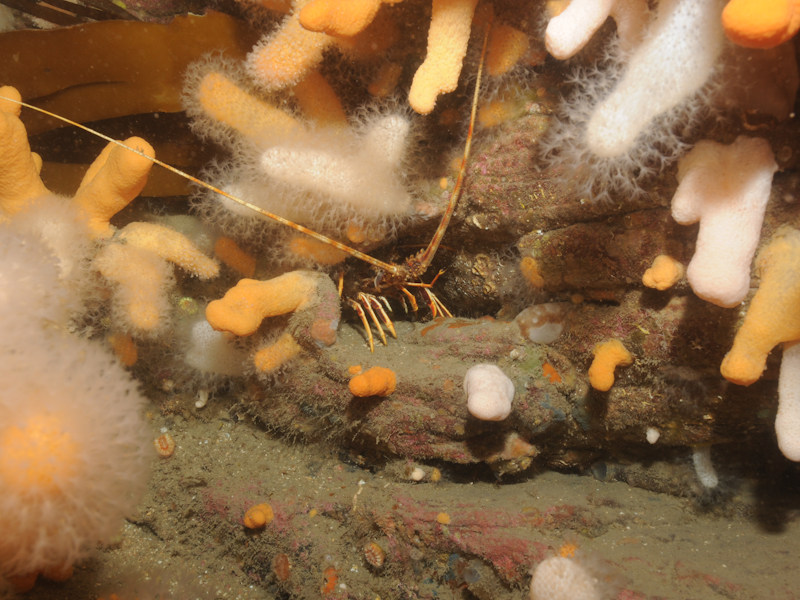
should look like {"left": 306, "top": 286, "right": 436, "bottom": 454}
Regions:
{"left": 542, "top": 0, "right": 724, "bottom": 200}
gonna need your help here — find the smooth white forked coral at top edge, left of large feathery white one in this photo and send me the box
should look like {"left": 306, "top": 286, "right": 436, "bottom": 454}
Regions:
{"left": 545, "top": 0, "right": 648, "bottom": 60}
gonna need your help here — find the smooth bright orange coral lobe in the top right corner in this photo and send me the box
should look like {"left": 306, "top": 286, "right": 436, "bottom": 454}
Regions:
{"left": 722, "top": 0, "right": 800, "bottom": 48}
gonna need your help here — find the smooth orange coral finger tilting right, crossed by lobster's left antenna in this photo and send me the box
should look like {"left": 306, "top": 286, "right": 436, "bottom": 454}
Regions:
{"left": 72, "top": 137, "right": 155, "bottom": 239}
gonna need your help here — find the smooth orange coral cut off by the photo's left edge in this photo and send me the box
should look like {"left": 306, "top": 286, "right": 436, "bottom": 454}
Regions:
{"left": 0, "top": 86, "right": 49, "bottom": 220}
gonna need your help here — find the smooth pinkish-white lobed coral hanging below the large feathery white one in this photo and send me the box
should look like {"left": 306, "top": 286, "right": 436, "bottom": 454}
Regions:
{"left": 672, "top": 136, "right": 778, "bottom": 307}
